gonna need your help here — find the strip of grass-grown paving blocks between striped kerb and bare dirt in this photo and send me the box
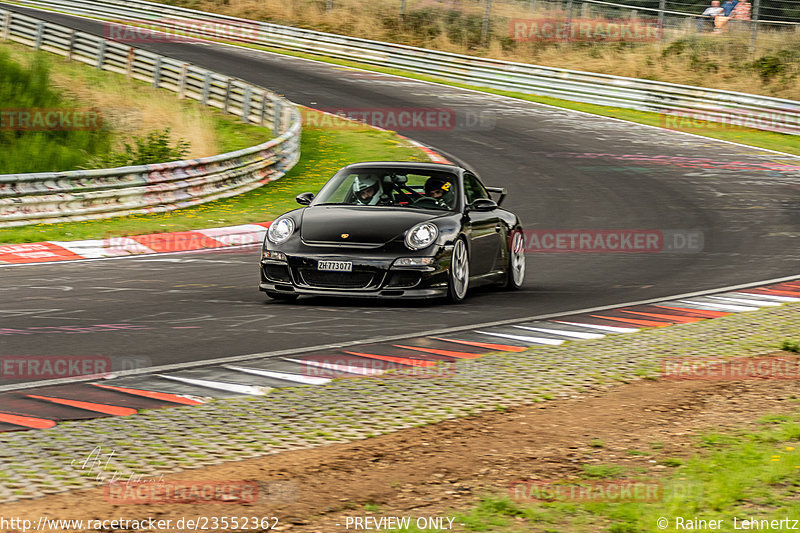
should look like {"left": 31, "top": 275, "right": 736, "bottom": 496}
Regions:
{"left": 0, "top": 304, "right": 800, "bottom": 503}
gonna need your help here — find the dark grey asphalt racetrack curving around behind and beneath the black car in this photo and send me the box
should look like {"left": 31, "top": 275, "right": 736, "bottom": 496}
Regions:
{"left": 0, "top": 5, "right": 800, "bottom": 384}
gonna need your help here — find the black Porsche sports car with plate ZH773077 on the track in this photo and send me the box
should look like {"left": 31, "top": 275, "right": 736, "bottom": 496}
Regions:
{"left": 260, "top": 162, "right": 525, "bottom": 302}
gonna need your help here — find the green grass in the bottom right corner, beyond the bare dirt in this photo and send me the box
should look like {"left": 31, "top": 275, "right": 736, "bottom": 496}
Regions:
{"left": 396, "top": 412, "right": 800, "bottom": 533}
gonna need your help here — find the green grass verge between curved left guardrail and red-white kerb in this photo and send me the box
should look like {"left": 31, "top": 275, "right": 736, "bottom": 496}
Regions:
{"left": 0, "top": 122, "right": 427, "bottom": 243}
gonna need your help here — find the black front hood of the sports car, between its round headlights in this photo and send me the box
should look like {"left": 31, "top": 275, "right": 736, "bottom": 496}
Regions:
{"left": 300, "top": 205, "right": 450, "bottom": 245}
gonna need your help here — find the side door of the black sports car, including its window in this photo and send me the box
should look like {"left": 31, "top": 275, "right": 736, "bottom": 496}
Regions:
{"left": 464, "top": 172, "right": 503, "bottom": 276}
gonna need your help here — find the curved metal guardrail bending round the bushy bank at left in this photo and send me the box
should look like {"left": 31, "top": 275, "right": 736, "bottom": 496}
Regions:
{"left": 0, "top": 9, "right": 301, "bottom": 227}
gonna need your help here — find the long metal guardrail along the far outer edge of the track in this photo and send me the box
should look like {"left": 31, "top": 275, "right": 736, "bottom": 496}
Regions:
{"left": 7, "top": 0, "right": 800, "bottom": 135}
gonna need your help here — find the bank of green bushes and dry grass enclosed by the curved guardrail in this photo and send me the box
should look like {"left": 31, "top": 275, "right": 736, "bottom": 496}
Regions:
{"left": 0, "top": 43, "right": 271, "bottom": 174}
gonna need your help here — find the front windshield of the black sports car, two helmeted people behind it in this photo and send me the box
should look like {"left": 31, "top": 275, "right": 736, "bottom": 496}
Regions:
{"left": 313, "top": 167, "right": 459, "bottom": 211}
